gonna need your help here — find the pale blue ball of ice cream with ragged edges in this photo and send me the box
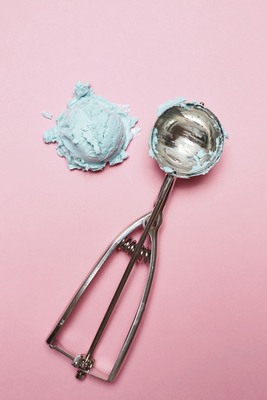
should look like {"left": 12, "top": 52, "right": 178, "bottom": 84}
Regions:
{"left": 43, "top": 81, "right": 140, "bottom": 171}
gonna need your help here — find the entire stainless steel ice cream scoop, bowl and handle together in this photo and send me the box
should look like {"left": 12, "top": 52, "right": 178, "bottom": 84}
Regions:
{"left": 47, "top": 103, "right": 224, "bottom": 382}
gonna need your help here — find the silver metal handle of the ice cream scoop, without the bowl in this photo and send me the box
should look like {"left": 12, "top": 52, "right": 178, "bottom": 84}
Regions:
{"left": 46, "top": 175, "right": 178, "bottom": 382}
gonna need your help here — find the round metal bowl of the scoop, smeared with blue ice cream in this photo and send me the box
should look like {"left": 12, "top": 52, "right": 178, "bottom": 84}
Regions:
{"left": 150, "top": 103, "right": 224, "bottom": 178}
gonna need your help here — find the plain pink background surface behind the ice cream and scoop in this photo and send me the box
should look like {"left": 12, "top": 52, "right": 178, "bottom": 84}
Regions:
{"left": 0, "top": 0, "right": 267, "bottom": 400}
